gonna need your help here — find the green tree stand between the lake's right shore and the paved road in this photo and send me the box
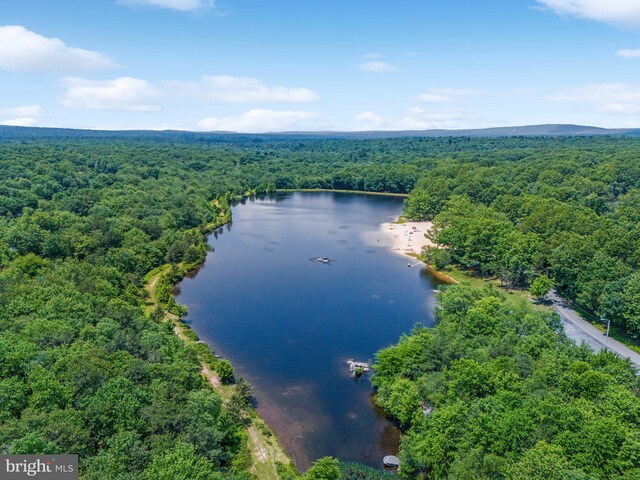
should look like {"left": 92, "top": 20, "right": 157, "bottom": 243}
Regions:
{"left": 373, "top": 285, "right": 640, "bottom": 480}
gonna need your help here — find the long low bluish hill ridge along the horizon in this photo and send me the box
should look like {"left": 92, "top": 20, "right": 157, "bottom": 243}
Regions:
{"left": 0, "top": 124, "right": 640, "bottom": 143}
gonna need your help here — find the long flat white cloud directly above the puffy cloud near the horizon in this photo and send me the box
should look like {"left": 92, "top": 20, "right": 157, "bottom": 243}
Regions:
{"left": 167, "top": 75, "right": 320, "bottom": 103}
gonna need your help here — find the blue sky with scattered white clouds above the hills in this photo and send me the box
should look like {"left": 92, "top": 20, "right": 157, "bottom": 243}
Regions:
{"left": 0, "top": 0, "right": 640, "bottom": 132}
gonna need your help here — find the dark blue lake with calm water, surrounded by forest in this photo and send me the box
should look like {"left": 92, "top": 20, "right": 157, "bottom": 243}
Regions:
{"left": 177, "top": 192, "right": 437, "bottom": 469}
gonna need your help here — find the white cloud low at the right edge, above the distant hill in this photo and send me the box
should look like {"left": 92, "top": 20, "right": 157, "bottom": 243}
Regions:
{"left": 550, "top": 83, "right": 640, "bottom": 115}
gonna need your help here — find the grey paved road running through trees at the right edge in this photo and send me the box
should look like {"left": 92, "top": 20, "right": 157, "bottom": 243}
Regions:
{"left": 546, "top": 290, "right": 640, "bottom": 370}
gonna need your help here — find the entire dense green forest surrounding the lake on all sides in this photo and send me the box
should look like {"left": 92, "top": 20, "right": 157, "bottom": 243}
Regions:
{"left": 0, "top": 137, "right": 640, "bottom": 480}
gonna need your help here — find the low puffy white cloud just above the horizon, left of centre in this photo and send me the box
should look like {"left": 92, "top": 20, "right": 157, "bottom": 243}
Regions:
{"left": 198, "top": 109, "right": 318, "bottom": 133}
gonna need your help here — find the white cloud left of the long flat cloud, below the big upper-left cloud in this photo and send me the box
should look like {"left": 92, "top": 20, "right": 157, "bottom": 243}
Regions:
{"left": 60, "top": 77, "right": 163, "bottom": 112}
